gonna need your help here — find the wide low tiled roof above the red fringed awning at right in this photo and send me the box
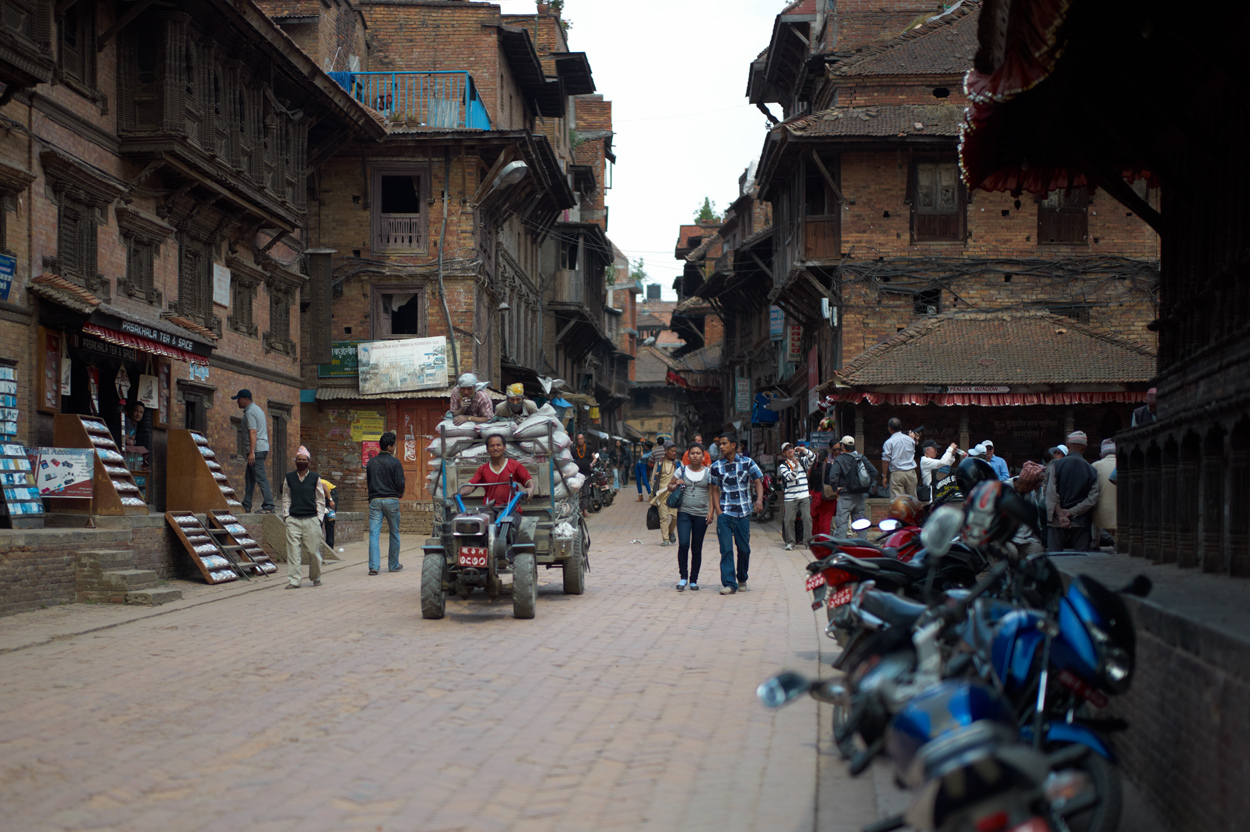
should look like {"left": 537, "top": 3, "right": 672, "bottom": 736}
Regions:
{"left": 836, "top": 311, "right": 1156, "bottom": 387}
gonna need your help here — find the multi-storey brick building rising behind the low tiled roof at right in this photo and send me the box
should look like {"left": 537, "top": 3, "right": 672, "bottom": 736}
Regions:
{"left": 705, "top": 2, "right": 1159, "bottom": 466}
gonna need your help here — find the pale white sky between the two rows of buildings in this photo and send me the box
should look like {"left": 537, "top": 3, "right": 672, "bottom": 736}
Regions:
{"left": 496, "top": 0, "right": 785, "bottom": 300}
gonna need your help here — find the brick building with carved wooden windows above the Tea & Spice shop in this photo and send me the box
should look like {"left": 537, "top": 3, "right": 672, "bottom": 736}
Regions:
{"left": 0, "top": 0, "right": 384, "bottom": 511}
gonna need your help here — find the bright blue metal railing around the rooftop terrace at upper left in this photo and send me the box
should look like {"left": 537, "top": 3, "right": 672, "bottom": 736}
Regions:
{"left": 329, "top": 71, "right": 490, "bottom": 130}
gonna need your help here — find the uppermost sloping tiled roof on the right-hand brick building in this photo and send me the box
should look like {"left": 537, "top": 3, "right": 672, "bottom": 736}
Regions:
{"left": 831, "top": 0, "right": 981, "bottom": 76}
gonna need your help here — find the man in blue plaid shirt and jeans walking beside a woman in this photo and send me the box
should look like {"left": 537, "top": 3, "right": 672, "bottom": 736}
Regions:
{"left": 708, "top": 433, "right": 764, "bottom": 595}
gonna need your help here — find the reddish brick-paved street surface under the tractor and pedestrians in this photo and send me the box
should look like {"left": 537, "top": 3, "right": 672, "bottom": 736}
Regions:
{"left": 0, "top": 492, "right": 875, "bottom": 832}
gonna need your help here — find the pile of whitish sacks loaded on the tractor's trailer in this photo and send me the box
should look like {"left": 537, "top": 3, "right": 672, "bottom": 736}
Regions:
{"left": 425, "top": 405, "right": 585, "bottom": 512}
